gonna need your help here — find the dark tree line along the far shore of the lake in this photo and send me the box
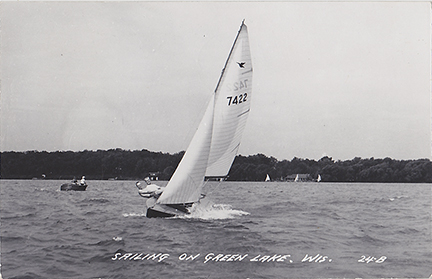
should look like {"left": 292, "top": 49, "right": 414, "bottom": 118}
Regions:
{"left": 1, "top": 149, "right": 432, "bottom": 183}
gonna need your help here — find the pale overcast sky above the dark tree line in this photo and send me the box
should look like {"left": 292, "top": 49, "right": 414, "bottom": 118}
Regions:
{"left": 0, "top": 2, "right": 431, "bottom": 160}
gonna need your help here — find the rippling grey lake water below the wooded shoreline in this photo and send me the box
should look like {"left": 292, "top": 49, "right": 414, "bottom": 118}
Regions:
{"left": 0, "top": 180, "right": 432, "bottom": 278}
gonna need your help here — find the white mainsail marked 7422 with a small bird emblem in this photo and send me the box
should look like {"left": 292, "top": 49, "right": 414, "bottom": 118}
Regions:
{"left": 206, "top": 24, "right": 252, "bottom": 177}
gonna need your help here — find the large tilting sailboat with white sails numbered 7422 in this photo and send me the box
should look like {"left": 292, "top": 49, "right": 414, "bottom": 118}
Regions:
{"left": 142, "top": 20, "right": 253, "bottom": 218}
